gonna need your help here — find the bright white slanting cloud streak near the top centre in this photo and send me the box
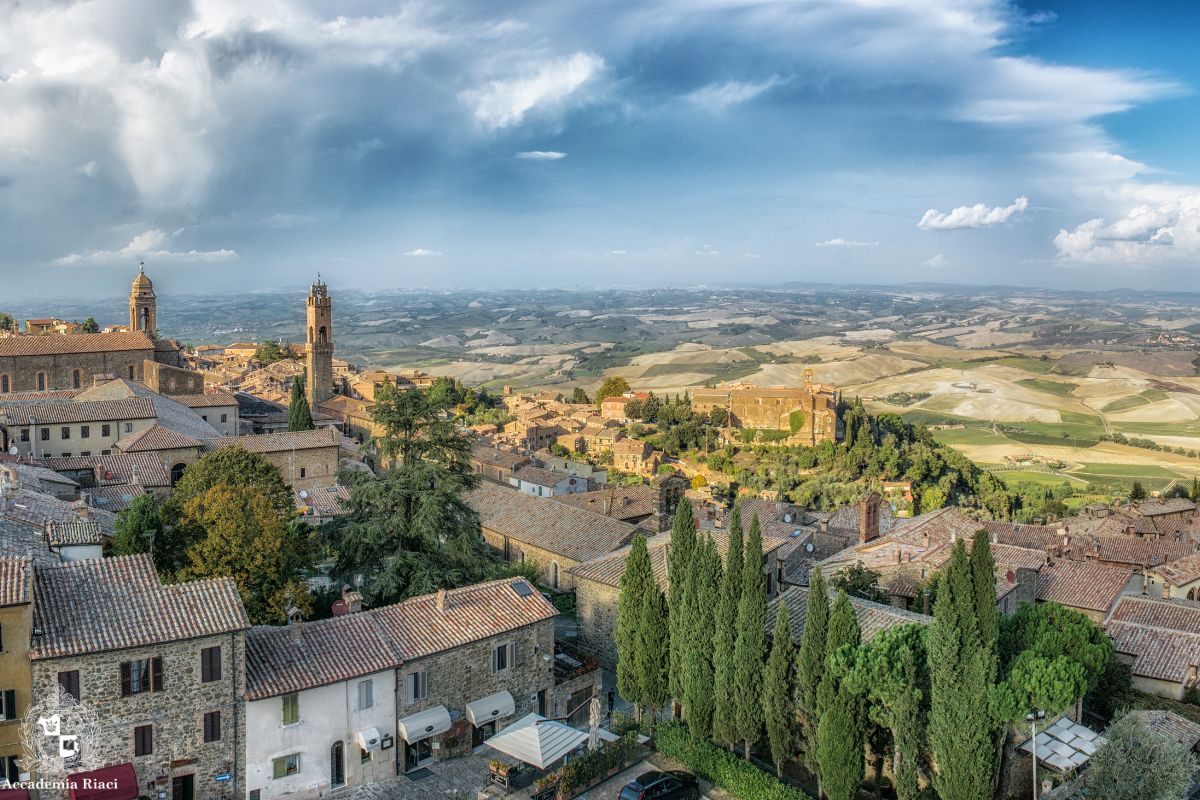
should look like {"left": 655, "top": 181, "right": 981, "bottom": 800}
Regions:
{"left": 458, "top": 52, "right": 605, "bottom": 131}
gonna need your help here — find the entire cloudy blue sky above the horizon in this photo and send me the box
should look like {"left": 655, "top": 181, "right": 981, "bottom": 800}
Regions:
{"left": 0, "top": 0, "right": 1200, "bottom": 296}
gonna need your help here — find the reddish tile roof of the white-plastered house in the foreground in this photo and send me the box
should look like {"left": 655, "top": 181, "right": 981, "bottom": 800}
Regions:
{"left": 246, "top": 612, "right": 401, "bottom": 700}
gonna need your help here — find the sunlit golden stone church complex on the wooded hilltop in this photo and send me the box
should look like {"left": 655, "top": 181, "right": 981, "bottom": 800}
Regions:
{"left": 691, "top": 369, "right": 838, "bottom": 447}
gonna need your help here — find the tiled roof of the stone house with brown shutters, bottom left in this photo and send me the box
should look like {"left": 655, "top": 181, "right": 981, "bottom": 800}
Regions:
{"left": 30, "top": 554, "right": 250, "bottom": 661}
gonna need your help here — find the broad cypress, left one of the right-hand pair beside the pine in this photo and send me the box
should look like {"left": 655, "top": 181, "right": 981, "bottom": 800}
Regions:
{"left": 928, "top": 539, "right": 997, "bottom": 800}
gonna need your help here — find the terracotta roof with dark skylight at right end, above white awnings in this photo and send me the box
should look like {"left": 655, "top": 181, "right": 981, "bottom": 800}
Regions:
{"left": 368, "top": 578, "right": 558, "bottom": 661}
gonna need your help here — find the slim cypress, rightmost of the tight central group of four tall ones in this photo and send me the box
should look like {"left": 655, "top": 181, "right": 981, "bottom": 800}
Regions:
{"left": 733, "top": 515, "right": 767, "bottom": 760}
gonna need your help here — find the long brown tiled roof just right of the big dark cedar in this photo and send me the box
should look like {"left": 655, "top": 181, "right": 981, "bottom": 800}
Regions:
{"left": 466, "top": 481, "right": 637, "bottom": 561}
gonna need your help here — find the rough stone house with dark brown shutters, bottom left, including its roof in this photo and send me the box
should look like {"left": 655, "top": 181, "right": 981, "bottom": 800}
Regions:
{"left": 30, "top": 554, "right": 250, "bottom": 800}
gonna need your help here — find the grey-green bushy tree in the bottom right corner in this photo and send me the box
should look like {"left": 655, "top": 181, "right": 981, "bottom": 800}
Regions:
{"left": 1086, "top": 714, "right": 1196, "bottom": 800}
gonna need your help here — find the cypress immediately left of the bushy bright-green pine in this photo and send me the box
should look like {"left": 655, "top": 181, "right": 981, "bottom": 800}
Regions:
{"left": 817, "top": 591, "right": 865, "bottom": 800}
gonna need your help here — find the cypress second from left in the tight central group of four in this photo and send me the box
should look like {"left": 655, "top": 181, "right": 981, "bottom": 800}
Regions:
{"left": 684, "top": 535, "right": 721, "bottom": 741}
